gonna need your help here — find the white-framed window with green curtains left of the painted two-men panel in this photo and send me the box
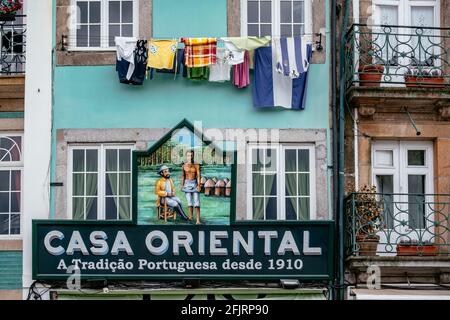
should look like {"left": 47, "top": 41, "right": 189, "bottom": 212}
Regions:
{"left": 68, "top": 144, "right": 133, "bottom": 220}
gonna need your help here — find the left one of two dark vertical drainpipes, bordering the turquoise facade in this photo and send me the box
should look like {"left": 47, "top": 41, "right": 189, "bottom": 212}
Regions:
{"left": 330, "top": 0, "right": 341, "bottom": 300}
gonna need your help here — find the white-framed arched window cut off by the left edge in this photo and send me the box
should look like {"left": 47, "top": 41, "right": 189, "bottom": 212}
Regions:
{"left": 0, "top": 134, "right": 23, "bottom": 236}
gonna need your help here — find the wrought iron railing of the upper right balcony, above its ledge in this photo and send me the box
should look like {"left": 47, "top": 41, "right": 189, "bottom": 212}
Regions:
{"left": 344, "top": 24, "right": 450, "bottom": 89}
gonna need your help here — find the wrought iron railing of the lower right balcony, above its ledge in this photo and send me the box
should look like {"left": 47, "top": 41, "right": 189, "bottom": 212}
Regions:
{"left": 346, "top": 193, "right": 450, "bottom": 256}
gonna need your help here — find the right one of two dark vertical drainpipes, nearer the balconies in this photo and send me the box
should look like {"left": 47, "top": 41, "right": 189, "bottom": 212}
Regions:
{"left": 338, "top": 0, "right": 350, "bottom": 300}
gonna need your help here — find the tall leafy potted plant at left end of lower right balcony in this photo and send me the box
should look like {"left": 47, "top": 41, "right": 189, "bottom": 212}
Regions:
{"left": 354, "top": 186, "right": 383, "bottom": 256}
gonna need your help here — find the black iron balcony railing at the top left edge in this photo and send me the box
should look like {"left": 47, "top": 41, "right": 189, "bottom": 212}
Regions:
{"left": 0, "top": 15, "right": 27, "bottom": 75}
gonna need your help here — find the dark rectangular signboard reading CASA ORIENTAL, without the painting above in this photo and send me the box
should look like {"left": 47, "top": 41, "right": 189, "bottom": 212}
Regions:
{"left": 33, "top": 224, "right": 332, "bottom": 279}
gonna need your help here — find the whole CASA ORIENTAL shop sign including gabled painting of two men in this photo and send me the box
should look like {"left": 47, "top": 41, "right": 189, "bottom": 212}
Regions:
{"left": 33, "top": 120, "right": 333, "bottom": 280}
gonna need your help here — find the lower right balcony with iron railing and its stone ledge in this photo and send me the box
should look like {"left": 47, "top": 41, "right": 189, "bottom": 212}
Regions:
{"left": 345, "top": 193, "right": 450, "bottom": 283}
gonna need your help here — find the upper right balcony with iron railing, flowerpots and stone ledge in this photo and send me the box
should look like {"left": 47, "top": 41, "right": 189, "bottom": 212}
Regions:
{"left": 344, "top": 24, "right": 450, "bottom": 120}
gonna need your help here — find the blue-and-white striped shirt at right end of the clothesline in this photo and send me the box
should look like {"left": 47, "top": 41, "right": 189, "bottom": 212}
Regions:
{"left": 272, "top": 37, "right": 309, "bottom": 79}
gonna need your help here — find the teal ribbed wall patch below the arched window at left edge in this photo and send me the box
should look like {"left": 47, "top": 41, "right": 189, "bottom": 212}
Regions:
{"left": 0, "top": 251, "right": 22, "bottom": 290}
